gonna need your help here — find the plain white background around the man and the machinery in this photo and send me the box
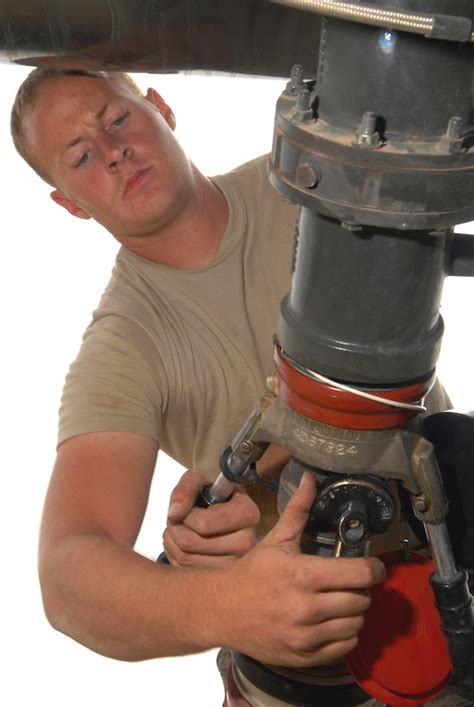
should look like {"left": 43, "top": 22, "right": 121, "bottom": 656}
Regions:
{"left": 0, "top": 65, "right": 474, "bottom": 707}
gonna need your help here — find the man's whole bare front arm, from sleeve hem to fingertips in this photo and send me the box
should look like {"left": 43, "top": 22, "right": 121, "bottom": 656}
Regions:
{"left": 40, "top": 433, "right": 383, "bottom": 667}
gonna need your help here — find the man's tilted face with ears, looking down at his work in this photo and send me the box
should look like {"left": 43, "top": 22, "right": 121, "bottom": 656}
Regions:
{"left": 25, "top": 76, "right": 193, "bottom": 241}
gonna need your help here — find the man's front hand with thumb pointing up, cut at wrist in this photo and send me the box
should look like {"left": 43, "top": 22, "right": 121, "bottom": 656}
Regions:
{"left": 217, "top": 472, "right": 385, "bottom": 667}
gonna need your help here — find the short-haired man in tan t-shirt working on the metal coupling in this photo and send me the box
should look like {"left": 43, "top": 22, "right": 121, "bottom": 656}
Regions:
{"left": 12, "top": 70, "right": 452, "bottom": 704}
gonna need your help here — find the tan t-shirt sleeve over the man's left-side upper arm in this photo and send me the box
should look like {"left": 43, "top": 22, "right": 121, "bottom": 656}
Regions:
{"left": 58, "top": 315, "right": 167, "bottom": 446}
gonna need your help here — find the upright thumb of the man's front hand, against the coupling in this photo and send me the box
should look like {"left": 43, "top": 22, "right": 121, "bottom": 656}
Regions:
{"left": 260, "top": 471, "right": 316, "bottom": 551}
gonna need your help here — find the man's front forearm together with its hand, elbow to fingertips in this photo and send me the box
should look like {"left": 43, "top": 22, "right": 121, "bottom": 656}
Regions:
{"left": 40, "top": 473, "right": 384, "bottom": 668}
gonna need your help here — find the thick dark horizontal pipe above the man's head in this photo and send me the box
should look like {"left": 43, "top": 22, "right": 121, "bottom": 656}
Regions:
{"left": 0, "top": 0, "right": 320, "bottom": 77}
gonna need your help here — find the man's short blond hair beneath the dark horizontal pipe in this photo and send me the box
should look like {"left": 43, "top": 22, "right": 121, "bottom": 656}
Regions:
{"left": 10, "top": 68, "right": 143, "bottom": 186}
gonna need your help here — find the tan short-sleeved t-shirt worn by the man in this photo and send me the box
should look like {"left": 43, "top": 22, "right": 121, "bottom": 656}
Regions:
{"left": 59, "top": 158, "right": 297, "bottom": 480}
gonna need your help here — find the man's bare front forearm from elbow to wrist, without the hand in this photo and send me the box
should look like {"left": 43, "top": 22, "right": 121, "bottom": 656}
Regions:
{"left": 40, "top": 534, "right": 229, "bottom": 661}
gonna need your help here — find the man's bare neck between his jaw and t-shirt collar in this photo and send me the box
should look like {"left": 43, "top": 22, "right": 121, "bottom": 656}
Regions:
{"left": 118, "top": 175, "right": 229, "bottom": 270}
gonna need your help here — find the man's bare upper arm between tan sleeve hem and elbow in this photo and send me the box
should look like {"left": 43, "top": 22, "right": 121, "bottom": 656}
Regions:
{"left": 41, "top": 432, "right": 158, "bottom": 551}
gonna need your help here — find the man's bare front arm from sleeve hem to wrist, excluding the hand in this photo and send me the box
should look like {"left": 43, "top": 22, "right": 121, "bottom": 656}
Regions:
{"left": 39, "top": 432, "right": 230, "bottom": 660}
